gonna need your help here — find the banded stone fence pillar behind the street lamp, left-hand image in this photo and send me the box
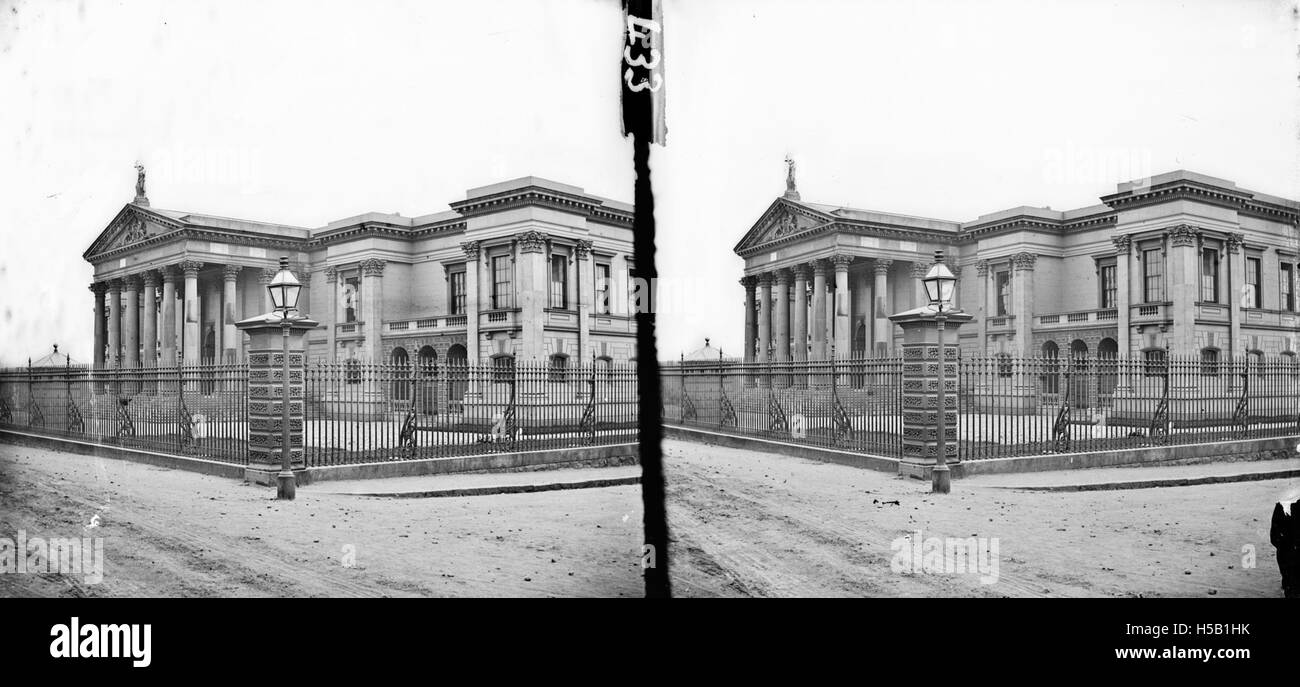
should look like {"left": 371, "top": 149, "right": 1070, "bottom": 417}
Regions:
{"left": 235, "top": 314, "right": 319, "bottom": 485}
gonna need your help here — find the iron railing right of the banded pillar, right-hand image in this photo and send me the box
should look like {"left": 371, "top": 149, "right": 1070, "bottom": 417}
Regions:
{"left": 957, "top": 350, "right": 1300, "bottom": 461}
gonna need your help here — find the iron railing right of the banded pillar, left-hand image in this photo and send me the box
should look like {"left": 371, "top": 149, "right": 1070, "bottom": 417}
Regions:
{"left": 303, "top": 357, "right": 638, "bottom": 467}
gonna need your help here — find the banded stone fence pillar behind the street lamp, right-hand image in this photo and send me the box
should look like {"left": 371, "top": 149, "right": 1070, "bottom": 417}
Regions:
{"left": 889, "top": 308, "right": 971, "bottom": 481}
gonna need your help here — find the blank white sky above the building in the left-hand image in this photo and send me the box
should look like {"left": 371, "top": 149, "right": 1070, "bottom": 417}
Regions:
{"left": 0, "top": 0, "right": 634, "bottom": 364}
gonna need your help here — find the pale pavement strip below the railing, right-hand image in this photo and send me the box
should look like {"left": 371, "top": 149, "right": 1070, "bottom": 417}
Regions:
{"left": 959, "top": 458, "right": 1300, "bottom": 492}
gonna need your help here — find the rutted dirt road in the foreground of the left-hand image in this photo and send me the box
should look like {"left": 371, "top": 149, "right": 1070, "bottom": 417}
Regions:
{"left": 0, "top": 444, "right": 644, "bottom": 596}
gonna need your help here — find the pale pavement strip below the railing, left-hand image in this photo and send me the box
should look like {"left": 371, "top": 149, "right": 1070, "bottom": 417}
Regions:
{"left": 299, "top": 466, "right": 641, "bottom": 498}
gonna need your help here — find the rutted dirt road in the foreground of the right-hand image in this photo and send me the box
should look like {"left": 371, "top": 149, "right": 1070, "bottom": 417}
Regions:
{"left": 664, "top": 441, "right": 1294, "bottom": 597}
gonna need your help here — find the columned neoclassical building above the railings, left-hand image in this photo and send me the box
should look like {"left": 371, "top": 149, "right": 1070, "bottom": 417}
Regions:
{"left": 83, "top": 175, "right": 636, "bottom": 367}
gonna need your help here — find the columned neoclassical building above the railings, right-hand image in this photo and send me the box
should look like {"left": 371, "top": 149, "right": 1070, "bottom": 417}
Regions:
{"left": 735, "top": 164, "right": 1300, "bottom": 362}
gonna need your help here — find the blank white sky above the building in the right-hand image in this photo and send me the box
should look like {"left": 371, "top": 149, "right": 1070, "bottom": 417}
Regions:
{"left": 653, "top": 0, "right": 1300, "bottom": 359}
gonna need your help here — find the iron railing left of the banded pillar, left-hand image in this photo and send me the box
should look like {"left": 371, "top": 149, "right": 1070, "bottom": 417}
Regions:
{"left": 0, "top": 364, "right": 248, "bottom": 465}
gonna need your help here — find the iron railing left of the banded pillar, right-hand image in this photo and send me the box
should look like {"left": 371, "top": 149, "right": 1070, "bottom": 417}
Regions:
{"left": 660, "top": 358, "right": 904, "bottom": 457}
